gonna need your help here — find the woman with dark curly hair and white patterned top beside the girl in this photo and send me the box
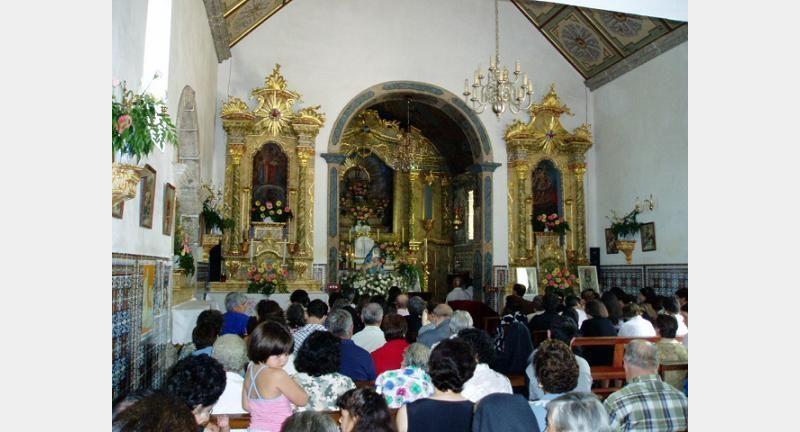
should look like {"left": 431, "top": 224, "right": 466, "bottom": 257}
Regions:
{"left": 292, "top": 331, "right": 356, "bottom": 411}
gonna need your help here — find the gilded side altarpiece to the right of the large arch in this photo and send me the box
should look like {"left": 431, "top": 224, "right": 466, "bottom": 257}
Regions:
{"left": 505, "top": 85, "right": 592, "bottom": 291}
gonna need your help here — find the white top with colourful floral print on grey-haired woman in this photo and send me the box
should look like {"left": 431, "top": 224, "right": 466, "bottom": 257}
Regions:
{"left": 375, "top": 367, "right": 434, "bottom": 408}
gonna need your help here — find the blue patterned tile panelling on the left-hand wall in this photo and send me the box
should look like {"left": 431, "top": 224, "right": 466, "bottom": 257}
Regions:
{"left": 111, "top": 254, "right": 172, "bottom": 402}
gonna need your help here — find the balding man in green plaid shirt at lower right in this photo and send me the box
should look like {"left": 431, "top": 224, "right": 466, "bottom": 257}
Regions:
{"left": 604, "top": 340, "right": 688, "bottom": 431}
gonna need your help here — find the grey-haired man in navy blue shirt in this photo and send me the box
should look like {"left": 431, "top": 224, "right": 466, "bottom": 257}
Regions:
{"left": 327, "top": 309, "right": 378, "bottom": 381}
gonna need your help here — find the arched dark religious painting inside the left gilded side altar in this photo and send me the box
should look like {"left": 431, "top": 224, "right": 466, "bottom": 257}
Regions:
{"left": 253, "top": 142, "right": 289, "bottom": 221}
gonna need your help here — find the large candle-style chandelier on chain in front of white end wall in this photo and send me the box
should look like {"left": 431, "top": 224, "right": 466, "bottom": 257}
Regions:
{"left": 464, "top": 0, "right": 533, "bottom": 119}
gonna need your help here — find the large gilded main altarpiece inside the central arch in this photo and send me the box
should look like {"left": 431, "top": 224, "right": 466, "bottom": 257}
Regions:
{"left": 332, "top": 109, "right": 454, "bottom": 297}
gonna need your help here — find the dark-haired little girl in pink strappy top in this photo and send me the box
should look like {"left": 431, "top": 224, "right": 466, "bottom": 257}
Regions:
{"left": 242, "top": 320, "right": 308, "bottom": 431}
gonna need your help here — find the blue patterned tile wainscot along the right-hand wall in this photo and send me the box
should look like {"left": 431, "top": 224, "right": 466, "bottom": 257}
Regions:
{"left": 598, "top": 264, "right": 689, "bottom": 296}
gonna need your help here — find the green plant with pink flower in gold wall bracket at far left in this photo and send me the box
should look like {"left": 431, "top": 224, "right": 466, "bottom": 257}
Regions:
{"left": 111, "top": 73, "right": 178, "bottom": 204}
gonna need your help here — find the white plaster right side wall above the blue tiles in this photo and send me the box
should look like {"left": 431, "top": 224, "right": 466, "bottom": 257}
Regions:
{"left": 590, "top": 42, "right": 689, "bottom": 265}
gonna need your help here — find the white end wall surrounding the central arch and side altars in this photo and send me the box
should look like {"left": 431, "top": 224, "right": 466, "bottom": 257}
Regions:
{"left": 209, "top": 0, "right": 594, "bottom": 265}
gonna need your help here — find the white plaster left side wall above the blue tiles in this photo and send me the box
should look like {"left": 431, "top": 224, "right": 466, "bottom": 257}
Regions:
{"left": 111, "top": 0, "right": 217, "bottom": 257}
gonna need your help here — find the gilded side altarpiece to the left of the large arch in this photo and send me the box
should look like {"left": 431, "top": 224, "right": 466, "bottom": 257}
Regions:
{"left": 211, "top": 65, "right": 325, "bottom": 291}
